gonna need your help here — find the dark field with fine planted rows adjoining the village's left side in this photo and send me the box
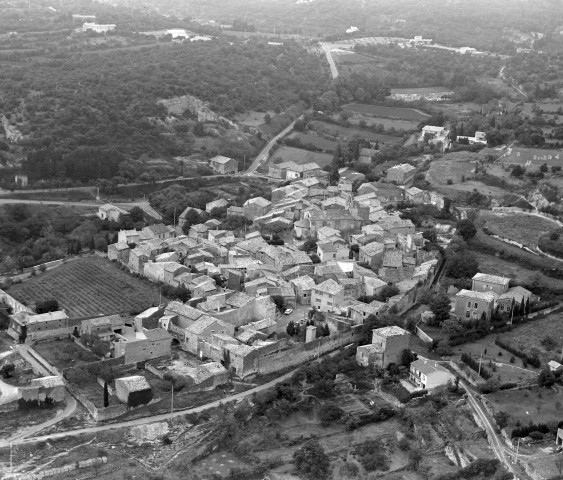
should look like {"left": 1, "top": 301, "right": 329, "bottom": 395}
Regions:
{"left": 9, "top": 256, "right": 165, "bottom": 318}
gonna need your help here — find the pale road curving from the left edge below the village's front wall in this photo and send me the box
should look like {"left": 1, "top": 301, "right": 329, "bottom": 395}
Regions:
{"left": 0, "top": 370, "right": 295, "bottom": 447}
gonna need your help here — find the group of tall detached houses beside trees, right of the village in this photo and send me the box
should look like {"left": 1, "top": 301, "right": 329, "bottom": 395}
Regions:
{"left": 454, "top": 273, "right": 533, "bottom": 322}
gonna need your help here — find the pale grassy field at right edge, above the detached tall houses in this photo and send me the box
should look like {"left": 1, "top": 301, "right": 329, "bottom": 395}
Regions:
{"left": 479, "top": 211, "right": 558, "bottom": 249}
